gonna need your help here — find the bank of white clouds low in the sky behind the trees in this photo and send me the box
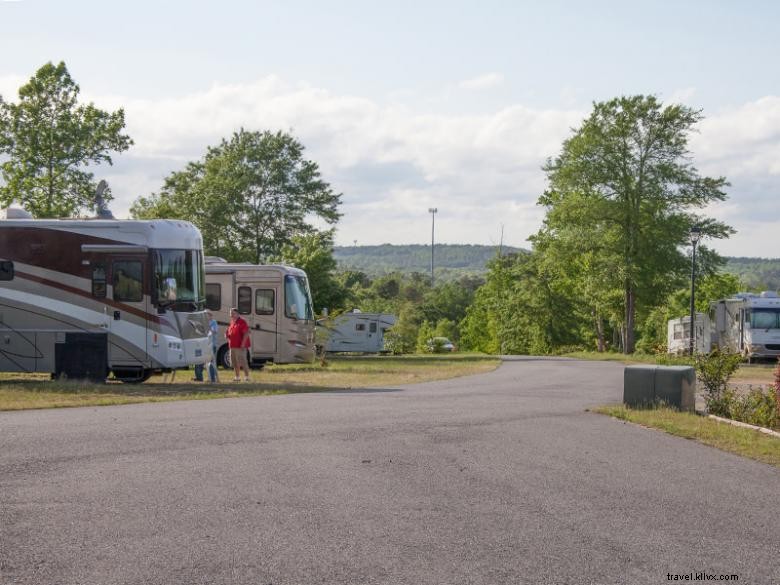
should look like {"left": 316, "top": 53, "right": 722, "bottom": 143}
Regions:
{"left": 6, "top": 77, "right": 780, "bottom": 256}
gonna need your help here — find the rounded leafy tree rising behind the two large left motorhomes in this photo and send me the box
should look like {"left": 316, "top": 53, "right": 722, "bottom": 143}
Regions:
{"left": 130, "top": 129, "right": 341, "bottom": 264}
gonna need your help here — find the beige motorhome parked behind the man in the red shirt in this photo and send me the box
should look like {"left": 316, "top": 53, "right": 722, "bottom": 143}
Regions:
{"left": 206, "top": 257, "right": 314, "bottom": 367}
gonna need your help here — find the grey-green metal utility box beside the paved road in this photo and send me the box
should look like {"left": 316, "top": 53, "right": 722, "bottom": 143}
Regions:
{"left": 623, "top": 366, "right": 696, "bottom": 412}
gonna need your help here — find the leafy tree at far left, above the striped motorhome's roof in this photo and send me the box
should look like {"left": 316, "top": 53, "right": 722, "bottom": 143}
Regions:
{"left": 0, "top": 62, "right": 133, "bottom": 217}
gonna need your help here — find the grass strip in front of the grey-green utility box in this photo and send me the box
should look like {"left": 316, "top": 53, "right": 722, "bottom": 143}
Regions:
{"left": 594, "top": 405, "right": 780, "bottom": 467}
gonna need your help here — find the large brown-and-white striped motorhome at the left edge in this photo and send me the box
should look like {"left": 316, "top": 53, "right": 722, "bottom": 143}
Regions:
{"left": 0, "top": 210, "right": 211, "bottom": 382}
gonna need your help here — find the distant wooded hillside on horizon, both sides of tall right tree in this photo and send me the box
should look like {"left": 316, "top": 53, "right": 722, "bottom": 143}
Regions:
{"left": 333, "top": 244, "right": 780, "bottom": 291}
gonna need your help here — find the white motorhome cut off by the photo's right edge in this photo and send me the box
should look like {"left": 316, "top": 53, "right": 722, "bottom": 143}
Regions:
{"left": 711, "top": 291, "right": 780, "bottom": 360}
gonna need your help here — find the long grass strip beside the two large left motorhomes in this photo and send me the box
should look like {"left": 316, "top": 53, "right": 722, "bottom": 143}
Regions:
{"left": 0, "top": 354, "right": 500, "bottom": 410}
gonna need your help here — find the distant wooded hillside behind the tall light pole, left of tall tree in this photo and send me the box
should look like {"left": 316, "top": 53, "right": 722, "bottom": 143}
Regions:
{"left": 333, "top": 244, "right": 520, "bottom": 278}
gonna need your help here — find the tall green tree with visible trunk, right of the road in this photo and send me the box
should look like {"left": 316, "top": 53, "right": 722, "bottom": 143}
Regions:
{"left": 536, "top": 95, "right": 733, "bottom": 353}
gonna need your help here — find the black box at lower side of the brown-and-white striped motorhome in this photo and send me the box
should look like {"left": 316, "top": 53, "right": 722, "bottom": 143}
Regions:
{"left": 54, "top": 333, "right": 108, "bottom": 382}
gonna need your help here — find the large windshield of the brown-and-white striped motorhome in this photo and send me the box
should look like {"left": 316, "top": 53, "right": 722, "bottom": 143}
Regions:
{"left": 152, "top": 250, "right": 206, "bottom": 310}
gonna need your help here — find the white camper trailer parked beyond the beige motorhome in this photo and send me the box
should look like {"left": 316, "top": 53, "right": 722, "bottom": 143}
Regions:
{"left": 322, "top": 311, "right": 396, "bottom": 353}
